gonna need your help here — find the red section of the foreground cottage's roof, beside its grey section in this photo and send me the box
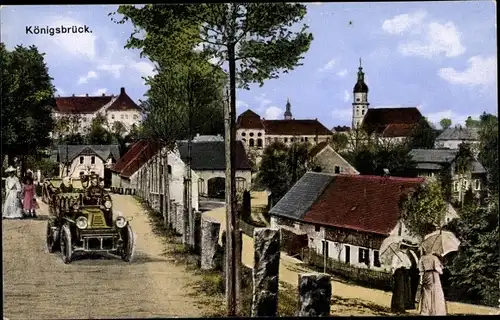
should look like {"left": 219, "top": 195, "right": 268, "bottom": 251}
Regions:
{"left": 303, "top": 175, "right": 424, "bottom": 235}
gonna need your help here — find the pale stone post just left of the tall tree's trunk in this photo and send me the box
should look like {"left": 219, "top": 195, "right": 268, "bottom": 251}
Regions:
{"left": 201, "top": 217, "right": 220, "bottom": 270}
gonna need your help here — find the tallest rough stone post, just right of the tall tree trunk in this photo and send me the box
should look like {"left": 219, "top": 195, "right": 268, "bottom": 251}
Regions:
{"left": 252, "top": 228, "right": 280, "bottom": 317}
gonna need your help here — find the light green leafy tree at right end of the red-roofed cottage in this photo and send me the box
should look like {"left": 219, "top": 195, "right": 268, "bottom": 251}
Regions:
{"left": 401, "top": 180, "right": 447, "bottom": 238}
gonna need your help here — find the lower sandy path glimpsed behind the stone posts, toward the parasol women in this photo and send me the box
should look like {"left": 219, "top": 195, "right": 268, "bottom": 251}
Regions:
{"left": 205, "top": 198, "right": 498, "bottom": 316}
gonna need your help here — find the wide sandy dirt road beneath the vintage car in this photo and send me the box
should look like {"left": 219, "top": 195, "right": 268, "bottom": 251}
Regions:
{"left": 2, "top": 195, "right": 205, "bottom": 320}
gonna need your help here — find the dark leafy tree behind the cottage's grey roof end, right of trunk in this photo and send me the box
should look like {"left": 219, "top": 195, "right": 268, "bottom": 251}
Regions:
{"left": 257, "top": 142, "right": 309, "bottom": 201}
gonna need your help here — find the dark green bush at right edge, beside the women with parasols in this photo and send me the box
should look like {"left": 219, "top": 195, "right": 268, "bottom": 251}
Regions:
{"left": 448, "top": 197, "right": 500, "bottom": 306}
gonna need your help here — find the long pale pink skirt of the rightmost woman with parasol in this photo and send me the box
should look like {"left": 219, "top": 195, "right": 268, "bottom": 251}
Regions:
{"left": 419, "top": 271, "right": 446, "bottom": 316}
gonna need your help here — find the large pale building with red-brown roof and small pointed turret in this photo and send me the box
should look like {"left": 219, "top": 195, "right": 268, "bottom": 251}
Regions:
{"left": 236, "top": 101, "right": 332, "bottom": 155}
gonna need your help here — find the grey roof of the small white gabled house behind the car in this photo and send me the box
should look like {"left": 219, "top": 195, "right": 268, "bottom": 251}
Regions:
{"left": 57, "top": 144, "right": 120, "bottom": 163}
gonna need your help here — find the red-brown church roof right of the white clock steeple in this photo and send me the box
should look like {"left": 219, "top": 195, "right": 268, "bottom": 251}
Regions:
{"left": 363, "top": 108, "right": 422, "bottom": 133}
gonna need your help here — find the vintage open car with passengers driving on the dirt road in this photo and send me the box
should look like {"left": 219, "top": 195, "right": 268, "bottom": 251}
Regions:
{"left": 47, "top": 179, "right": 135, "bottom": 263}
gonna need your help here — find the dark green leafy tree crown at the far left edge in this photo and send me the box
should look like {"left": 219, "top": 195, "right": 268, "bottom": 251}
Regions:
{"left": 0, "top": 43, "right": 55, "bottom": 170}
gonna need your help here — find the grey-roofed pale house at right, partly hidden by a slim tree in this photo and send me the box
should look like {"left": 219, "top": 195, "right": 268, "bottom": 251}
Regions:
{"left": 410, "top": 149, "right": 487, "bottom": 201}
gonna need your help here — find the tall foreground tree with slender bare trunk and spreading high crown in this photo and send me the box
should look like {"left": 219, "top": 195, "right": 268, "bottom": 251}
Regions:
{"left": 113, "top": 3, "right": 313, "bottom": 315}
